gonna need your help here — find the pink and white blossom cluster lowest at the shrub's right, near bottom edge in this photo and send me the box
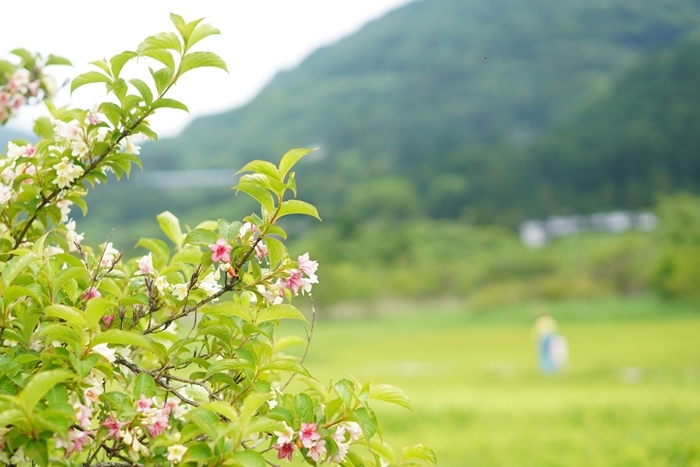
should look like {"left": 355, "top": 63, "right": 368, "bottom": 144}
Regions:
{"left": 274, "top": 422, "right": 362, "bottom": 464}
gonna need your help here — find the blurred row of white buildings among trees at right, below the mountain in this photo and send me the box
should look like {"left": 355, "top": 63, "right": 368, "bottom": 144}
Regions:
{"left": 520, "top": 211, "right": 657, "bottom": 248}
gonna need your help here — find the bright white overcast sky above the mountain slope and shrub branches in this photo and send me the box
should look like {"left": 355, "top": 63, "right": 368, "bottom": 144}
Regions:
{"left": 0, "top": 0, "right": 410, "bottom": 136}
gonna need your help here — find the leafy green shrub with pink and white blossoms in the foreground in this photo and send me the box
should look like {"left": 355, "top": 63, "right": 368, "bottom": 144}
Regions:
{"left": 0, "top": 15, "right": 436, "bottom": 467}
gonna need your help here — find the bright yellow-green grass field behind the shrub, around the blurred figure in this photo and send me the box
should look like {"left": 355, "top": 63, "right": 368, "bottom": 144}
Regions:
{"left": 284, "top": 298, "right": 700, "bottom": 467}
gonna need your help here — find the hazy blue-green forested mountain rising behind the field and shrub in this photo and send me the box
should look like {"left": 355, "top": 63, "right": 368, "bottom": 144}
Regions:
{"left": 80, "top": 0, "right": 700, "bottom": 249}
